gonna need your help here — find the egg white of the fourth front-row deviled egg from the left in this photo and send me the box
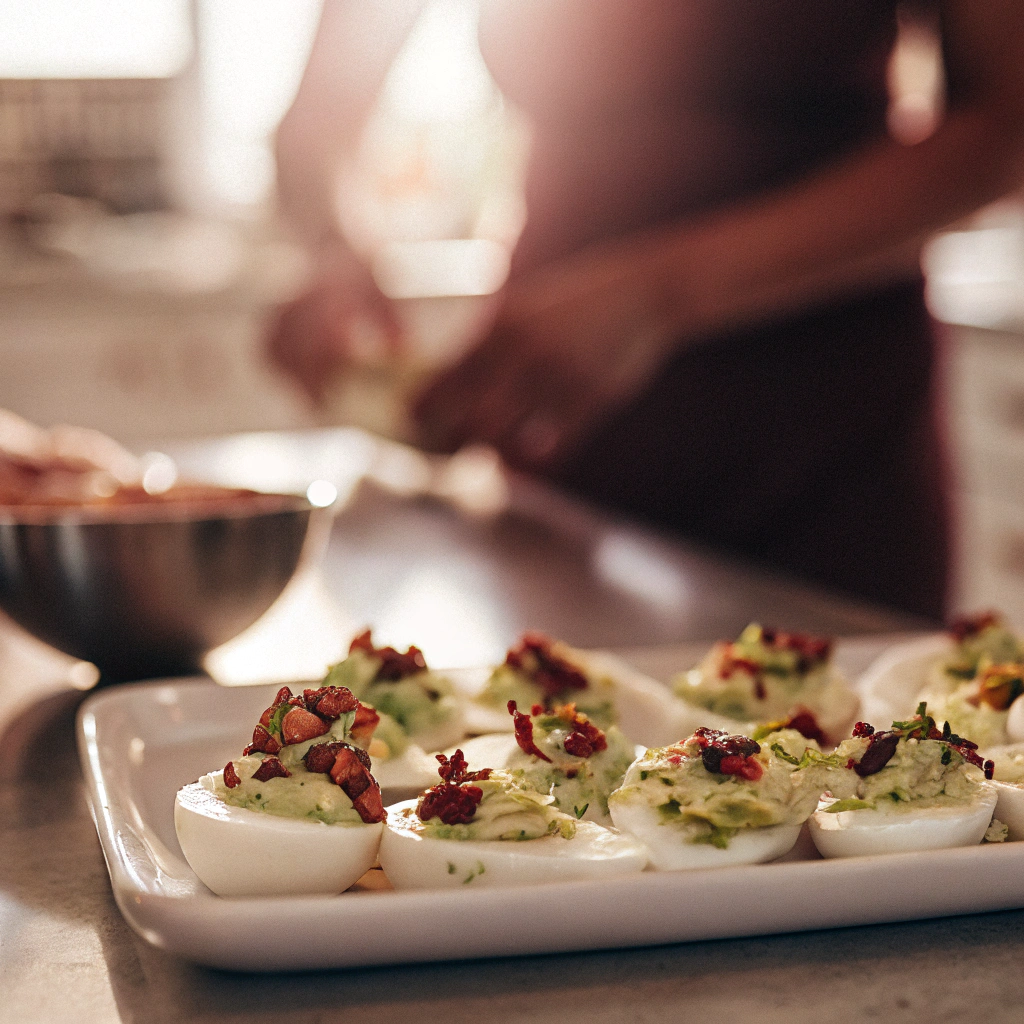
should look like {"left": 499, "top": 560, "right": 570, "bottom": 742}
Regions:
{"left": 809, "top": 782, "right": 1002, "bottom": 857}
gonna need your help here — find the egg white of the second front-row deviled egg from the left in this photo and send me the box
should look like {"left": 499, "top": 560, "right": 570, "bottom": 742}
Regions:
{"left": 380, "top": 800, "right": 647, "bottom": 889}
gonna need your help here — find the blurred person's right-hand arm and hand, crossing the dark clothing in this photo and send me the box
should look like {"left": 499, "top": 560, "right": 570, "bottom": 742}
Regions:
{"left": 419, "top": 0, "right": 1024, "bottom": 464}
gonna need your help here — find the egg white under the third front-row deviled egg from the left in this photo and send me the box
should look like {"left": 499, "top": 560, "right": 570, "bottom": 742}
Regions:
{"left": 609, "top": 800, "right": 800, "bottom": 871}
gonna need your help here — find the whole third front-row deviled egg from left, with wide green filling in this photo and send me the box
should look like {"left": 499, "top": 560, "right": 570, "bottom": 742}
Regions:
{"left": 608, "top": 728, "right": 835, "bottom": 871}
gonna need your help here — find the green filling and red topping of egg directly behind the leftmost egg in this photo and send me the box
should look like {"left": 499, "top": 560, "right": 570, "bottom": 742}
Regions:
{"left": 324, "top": 630, "right": 465, "bottom": 752}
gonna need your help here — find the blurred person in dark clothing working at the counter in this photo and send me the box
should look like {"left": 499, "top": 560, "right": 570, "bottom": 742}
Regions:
{"left": 270, "top": 0, "right": 1024, "bottom": 620}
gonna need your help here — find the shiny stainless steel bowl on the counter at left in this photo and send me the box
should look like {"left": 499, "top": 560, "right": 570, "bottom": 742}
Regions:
{"left": 0, "top": 495, "right": 331, "bottom": 681}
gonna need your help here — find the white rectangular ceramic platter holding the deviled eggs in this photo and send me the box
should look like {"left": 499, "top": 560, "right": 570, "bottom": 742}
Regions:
{"left": 78, "top": 639, "right": 1024, "bottom": 971}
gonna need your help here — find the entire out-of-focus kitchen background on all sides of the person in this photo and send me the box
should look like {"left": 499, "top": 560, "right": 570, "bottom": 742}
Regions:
{"left": 0, "top": 0, "right": 1024, "bottom": 627}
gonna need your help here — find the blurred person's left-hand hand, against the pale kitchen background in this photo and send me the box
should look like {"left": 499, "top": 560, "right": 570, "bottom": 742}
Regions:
{"left": 266, "top": 244, "right": 401, "bottom": 404}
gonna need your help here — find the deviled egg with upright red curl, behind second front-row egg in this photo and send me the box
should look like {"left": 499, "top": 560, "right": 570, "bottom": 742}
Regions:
{"left": 462, "top": 700, "right": 636, "bottom": 825}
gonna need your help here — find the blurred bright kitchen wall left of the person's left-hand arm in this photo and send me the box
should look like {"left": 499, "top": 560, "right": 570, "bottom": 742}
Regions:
{"left": 0, "top": 0, "right": 319, "bottom": 445}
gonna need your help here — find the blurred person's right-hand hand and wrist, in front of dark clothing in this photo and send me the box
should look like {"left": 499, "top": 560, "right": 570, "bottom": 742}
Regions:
{"left": 414, "top": 243, "right": 676, "bottom": 468}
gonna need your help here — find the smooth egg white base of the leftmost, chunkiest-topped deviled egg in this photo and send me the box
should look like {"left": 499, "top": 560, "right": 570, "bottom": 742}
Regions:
{"left": 174, "top": 772, "right": 384, "bottom": 896}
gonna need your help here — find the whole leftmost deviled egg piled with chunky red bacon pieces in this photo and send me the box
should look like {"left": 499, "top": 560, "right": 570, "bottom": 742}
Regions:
{"left": 174, "top": 686, "right": 385, "bottom": 896}
